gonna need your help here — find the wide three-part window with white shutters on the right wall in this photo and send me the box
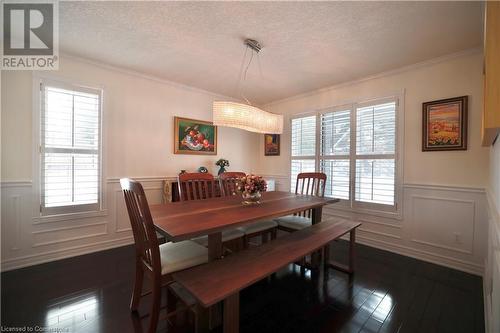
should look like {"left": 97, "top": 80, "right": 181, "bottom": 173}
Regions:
{"left": 291, "top": 98, "right": 399, "bottom": 211}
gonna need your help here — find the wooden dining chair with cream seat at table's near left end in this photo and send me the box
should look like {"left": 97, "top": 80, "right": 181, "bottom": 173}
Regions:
{"left": 120, "top": 178, "right": 208, "bottom": 333}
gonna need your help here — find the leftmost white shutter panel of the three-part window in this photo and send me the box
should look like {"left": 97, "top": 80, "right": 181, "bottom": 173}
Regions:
{"left": 290, "top": 116, "right": 316, "bottom": 192}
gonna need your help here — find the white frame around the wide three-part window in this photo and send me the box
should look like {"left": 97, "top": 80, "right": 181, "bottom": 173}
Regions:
{"left": 288, "top": 90, "right": 404, "bottom": 219}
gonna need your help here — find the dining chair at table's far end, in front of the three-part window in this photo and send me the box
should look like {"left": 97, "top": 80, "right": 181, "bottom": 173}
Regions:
{"left": 274, "top": 172, "right": 326, "bottom": 232}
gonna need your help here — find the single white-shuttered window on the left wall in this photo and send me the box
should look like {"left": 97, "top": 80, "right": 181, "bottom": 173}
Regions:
{"left": 40, "top": 82, "right": 101, "bottom": 215}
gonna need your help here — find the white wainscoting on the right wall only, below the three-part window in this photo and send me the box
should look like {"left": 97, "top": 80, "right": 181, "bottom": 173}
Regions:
{"left": 266, "top": 175, "right": 488, "bottom": 275}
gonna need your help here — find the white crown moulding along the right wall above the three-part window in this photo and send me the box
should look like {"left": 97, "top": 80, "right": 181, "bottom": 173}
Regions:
{"left": 263, "top": 47, "right": 482, "bottom": 108}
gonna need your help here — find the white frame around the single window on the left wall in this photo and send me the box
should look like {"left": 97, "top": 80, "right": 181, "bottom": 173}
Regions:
{"left": 33, "top": 76, "right": 105, "bottom": 221}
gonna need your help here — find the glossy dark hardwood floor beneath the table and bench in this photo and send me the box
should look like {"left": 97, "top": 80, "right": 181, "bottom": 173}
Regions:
{"left": 1, "top": 241, "right": 484, "bottom": 333}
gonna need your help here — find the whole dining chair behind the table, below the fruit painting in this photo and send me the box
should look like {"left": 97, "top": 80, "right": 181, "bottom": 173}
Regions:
{"left": 178, "top": 172, "right": 245, "bottom": 250}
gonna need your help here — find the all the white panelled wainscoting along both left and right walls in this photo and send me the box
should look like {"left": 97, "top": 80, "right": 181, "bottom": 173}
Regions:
{"left": 1, "top": 175, "right": 488, "bottom": 274}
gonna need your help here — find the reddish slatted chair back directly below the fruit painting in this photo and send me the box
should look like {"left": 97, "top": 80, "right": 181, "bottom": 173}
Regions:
{"left": 178, "top": 172, "right": 216, "bottom": 201}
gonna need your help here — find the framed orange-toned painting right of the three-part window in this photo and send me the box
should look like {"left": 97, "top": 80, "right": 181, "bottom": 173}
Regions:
{"left": 422, "top": 96, "right": 468, "bottom": 151}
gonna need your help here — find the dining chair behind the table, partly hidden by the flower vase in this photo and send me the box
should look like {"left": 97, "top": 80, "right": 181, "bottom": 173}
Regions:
{"left": 219, "top": 172, "right": 278, "bottom": 248}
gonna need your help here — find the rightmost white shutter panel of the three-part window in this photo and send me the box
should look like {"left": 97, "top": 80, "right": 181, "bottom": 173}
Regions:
{"left": 355, "top": 101, "right": 396, "bottom": 205}
